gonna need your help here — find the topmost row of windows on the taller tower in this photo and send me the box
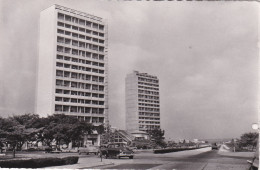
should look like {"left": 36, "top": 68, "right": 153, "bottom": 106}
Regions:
{"left": 58, "top": 12, "right": 104, "bottom": 30}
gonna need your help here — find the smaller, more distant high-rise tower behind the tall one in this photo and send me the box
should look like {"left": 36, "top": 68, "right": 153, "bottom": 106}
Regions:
{"left": 125, "top": 71, "right": 160, "bottom": 133}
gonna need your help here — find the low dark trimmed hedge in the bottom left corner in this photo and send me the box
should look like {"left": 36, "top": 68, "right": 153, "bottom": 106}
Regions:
{"left": 0, "top": 156, "right": 79, "bottom": 168}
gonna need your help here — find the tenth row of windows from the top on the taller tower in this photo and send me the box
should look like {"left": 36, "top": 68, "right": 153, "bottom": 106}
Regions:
{"left": 55, "top": 89, "right": 104, "bottom": 99}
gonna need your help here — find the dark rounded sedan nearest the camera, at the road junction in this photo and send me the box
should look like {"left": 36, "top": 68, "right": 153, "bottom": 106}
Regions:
{"left": 100, "top": 143, "right": 134, "bottom": 159}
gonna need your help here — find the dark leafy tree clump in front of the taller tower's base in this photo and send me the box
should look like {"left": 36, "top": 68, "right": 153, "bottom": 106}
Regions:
{"left": 0, "top": 114, "right": 95, "bottom": 157}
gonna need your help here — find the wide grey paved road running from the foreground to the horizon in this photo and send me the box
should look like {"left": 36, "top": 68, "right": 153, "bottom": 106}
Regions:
{"left": 93, "top": 149, "right": 248, "bottom": 170}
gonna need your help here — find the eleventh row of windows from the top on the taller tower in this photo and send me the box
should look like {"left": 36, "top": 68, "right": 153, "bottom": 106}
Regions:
{"left": 55, "top": 97, "right": 105, "bottom": 105}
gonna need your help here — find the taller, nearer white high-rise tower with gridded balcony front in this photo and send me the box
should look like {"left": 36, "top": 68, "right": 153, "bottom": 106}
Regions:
{"left": 36, "top": 5, "right": 108, "bottom": 143}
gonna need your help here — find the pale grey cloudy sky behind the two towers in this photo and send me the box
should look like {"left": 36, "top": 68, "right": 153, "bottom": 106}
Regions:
{"left": 0, "top": 0, "right": 259, "bottom": 139}
